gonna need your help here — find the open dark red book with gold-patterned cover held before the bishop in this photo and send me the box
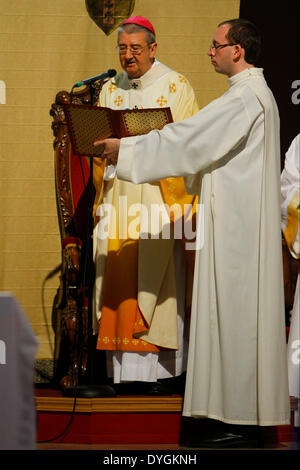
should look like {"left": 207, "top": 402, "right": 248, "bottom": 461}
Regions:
{"left": 63, "top": 103, "right": 173, "bottom": 157}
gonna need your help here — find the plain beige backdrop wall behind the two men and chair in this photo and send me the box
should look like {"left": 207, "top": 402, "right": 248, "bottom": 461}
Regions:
{"left": 0, "top": 0, "right": 239, "bottom": 358}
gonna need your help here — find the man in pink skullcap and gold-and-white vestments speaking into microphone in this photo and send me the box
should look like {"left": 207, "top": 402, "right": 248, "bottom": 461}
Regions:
{"left": 94, "top": 17, "right": 199, "bottom": 383}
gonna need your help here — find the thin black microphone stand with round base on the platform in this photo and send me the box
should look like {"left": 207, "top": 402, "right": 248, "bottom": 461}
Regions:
{"left": 63, "top": 84, "right": 116, "bottom": 398}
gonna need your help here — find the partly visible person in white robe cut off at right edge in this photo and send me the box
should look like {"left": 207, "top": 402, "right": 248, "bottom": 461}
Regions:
{"left": 281, "top": 134, "right": 300, "bottom": 427}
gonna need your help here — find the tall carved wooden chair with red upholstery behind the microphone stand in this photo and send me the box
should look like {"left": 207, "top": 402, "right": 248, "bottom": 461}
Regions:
{"left": 50, "top": 80, "right": 104, "bottom": 389}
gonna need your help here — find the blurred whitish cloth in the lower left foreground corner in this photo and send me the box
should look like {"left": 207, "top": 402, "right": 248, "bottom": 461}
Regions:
{"left": 0, "top": 292, "right": 37, "bottom": 450}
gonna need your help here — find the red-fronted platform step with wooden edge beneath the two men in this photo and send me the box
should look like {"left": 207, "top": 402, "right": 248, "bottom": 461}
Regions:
{"left": 35, "top": 389, "right": 296, "bottom": 445}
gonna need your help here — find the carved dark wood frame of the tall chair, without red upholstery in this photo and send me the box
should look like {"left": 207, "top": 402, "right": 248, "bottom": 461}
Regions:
{"left": 50, "top": 80, "right": 104, "bottom": 388}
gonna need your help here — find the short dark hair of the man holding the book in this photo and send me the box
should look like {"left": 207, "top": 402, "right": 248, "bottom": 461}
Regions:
{"left": 218, "top": 18, "right": 261, "bottom": 65}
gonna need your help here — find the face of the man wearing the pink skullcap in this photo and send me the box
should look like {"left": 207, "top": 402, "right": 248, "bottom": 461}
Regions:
{"left": 118, "top": 31, "right": 157, "bottom": 78}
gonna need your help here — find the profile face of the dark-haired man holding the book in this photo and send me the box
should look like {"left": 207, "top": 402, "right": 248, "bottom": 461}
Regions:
{"left": 208, "top": 24, "right": 236, "bottom": 77}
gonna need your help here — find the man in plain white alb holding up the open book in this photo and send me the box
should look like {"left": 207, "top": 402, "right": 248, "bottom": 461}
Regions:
{"left": 95, "top": 19, "right": 290, "bottom": 436}
